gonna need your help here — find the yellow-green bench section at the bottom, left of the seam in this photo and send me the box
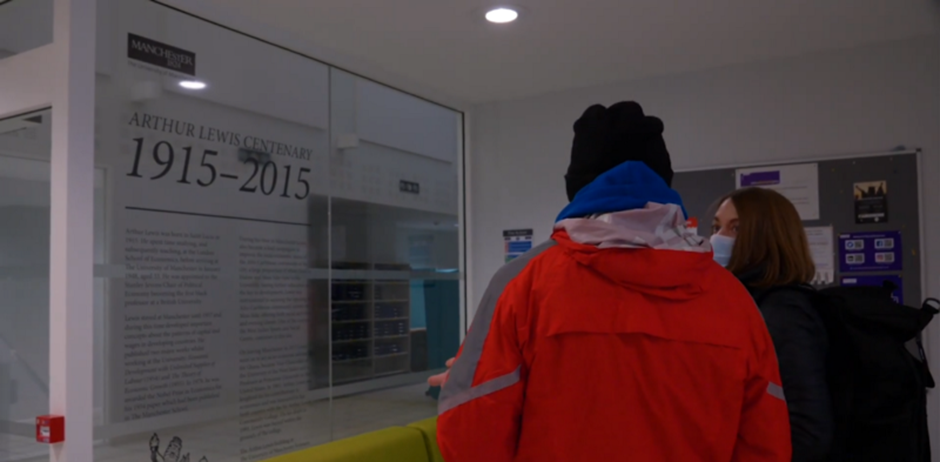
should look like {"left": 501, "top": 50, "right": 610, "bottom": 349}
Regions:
{"left": 268, "top": 427, "right": 431, "bottom": 462}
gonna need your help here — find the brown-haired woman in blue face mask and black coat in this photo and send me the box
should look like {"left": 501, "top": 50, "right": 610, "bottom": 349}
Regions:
{"left": 711, "top": 188, "right": 833, "bottom": 462}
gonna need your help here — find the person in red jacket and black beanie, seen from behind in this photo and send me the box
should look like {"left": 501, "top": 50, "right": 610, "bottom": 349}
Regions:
{"left": 438, "top": 102, "right": 791, "bottom": 462}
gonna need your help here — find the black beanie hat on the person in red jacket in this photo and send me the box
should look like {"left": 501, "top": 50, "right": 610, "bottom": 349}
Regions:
{"left": 565, "top": 101, "right": 672, "bottom": 201}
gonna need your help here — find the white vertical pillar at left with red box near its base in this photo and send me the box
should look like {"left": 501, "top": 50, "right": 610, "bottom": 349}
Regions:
{"left": 49, "top": 0, "right": 96, "bottom": 462}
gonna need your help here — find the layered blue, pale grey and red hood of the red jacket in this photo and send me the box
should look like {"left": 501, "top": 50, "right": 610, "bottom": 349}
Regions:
{"left": 552, "top": 162, "right": 718, "bottom": 300}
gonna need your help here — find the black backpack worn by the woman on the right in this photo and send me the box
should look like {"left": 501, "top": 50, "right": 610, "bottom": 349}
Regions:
{"left": 762, "top": 282, "right": 940, "bottom": 462}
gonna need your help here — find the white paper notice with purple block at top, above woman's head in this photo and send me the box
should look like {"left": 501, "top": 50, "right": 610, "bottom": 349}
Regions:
{"left": 735, "top": 164, "right": 819, "bottom": 221}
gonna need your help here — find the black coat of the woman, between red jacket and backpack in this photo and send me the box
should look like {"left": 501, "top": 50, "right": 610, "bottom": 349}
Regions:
{"left": 742, "top": 278, "right": 833, "bottom": 462}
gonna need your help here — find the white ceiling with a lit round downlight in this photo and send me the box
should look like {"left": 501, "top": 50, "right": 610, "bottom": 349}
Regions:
{"left": 193, "top": 0, "right": 940, "bottom": 103}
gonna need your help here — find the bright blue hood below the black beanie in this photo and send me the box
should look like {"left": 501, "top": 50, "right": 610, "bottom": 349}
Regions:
{"left": 557, "top": 161, "right": 689, "bottom": 221}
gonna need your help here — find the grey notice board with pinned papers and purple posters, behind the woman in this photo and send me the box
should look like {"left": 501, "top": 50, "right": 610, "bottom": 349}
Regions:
{"left": 673, "top": 149, "right": 921, "bottom": 304}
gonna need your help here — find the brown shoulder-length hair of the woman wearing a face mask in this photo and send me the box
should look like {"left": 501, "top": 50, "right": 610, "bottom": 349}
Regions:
{"left": 721, "top": 188, "right": 816, "bottom": 288}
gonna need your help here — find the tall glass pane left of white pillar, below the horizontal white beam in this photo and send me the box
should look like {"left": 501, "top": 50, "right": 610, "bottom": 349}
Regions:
{"left": 0, "top": 110, "right": 51, "bottom": 461}
